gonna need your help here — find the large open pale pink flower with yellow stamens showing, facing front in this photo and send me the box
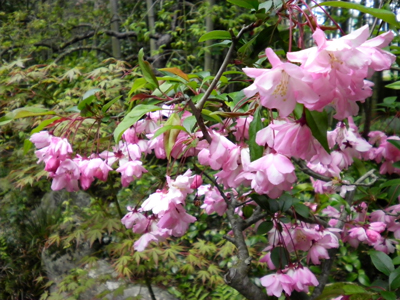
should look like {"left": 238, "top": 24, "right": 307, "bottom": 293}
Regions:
{"left": 243, "top": 48, "right": 319, "bottom": 117}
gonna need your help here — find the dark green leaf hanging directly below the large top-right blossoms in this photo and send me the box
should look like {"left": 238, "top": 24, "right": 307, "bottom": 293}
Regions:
{"left": 305, "top": 109, "right": 330, "bottom": 153}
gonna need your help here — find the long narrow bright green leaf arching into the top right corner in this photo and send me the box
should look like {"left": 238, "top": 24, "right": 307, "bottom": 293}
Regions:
{"left": 319, "top": 1, "right": 399, "bottom": 27}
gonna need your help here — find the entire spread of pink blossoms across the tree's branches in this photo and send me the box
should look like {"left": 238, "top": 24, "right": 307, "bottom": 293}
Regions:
{"left": 27, "top": 26, "right": 400, "bottom": 297}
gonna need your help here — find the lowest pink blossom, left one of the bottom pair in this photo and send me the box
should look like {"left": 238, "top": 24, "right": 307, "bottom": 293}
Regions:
{"left": 260, "top": 273, "right": 295, "bottom": 297}
